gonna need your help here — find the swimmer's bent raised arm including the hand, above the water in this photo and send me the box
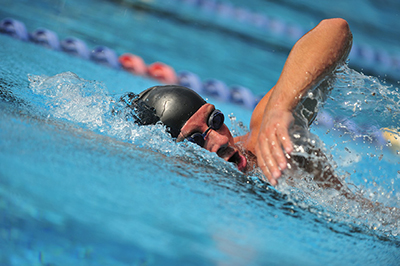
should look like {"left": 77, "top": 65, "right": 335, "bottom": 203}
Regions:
{"left": 241, "top": 19, "right": 352, "bottom": 185}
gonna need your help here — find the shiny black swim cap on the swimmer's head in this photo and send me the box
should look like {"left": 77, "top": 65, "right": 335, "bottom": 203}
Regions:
{"left": 138, "top": 85, "right": 206, "bottom": 138}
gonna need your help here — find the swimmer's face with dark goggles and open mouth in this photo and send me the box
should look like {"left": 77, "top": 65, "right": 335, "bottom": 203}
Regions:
{"left": 177, "top": 103, "right": 247, "bottom": 172}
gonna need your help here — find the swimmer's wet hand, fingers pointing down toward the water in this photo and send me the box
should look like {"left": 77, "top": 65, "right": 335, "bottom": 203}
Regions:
{"left": 255, "top": 109, "right": 294, "bottom": 186}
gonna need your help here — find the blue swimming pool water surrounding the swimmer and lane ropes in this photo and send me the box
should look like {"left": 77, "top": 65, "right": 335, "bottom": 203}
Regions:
{"left": 0, "top": 1, "right": 400, "bottom": 265}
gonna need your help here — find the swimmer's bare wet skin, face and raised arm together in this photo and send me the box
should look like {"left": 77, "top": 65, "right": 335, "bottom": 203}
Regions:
{"left": 178, "top": 18, "right": 352, "bottom": 186}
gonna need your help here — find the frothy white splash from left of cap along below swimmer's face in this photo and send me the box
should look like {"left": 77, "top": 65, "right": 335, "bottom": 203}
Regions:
{"left": 25, "top": 72, "right": 242, "bottom": 177}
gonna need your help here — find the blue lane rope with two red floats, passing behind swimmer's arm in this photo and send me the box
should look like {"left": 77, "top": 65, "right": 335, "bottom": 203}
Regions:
{"left": 0, "top": 18, "right": 394, "bottom": 149}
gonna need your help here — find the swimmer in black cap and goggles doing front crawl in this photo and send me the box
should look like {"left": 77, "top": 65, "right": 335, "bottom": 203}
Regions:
{"left": 125, "top": 18, "right": 352, "bottom": 189}
